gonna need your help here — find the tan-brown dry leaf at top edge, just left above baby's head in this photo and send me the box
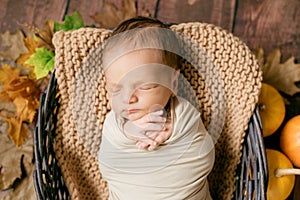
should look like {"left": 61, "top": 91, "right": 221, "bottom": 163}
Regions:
{"left": 91, "top": 0, "right": 137, "bottom": 28}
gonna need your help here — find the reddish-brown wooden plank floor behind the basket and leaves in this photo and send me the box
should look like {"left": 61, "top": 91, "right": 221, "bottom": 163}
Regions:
{"left": 0, "top": 0, "right": 300, "bottom": 200}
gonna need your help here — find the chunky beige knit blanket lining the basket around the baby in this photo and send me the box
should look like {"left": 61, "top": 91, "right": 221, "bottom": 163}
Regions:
{"left": 53, "top": 23, "right": 262, "bottom": 199}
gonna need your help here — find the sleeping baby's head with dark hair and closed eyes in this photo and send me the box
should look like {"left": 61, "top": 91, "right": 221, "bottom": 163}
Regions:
{"left": 103, "top": 17, "right": 179, "bottom": 120}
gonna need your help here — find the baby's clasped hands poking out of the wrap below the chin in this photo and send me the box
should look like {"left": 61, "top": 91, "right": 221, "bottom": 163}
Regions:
{"left": 123, "top": 110, "right": 171, "bottom": 150}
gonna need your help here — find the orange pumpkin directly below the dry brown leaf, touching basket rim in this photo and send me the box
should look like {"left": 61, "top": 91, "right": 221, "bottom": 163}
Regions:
{"left": 258, "top": 83, "right": 285, "bottom": 137}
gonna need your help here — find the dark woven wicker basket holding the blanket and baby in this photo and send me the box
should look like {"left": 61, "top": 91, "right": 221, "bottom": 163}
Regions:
{"left": 34, "top": 22, "right": 268, "bottom": 200}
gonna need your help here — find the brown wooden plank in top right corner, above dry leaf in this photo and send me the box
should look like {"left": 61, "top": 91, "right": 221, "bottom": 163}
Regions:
{"left": 233, "top": 0, "right": 300, "bottom": 62}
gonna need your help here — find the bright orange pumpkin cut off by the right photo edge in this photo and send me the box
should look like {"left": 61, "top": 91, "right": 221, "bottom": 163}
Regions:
{"left": 280, "top": 115, "right": 300, "bottom": 167}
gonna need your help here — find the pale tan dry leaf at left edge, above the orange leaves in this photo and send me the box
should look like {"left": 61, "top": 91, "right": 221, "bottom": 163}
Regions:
{"left": 0, "top": 30, "right": 27, "bottom": 60}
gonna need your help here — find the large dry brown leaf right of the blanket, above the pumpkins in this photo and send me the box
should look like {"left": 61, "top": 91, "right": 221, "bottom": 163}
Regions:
{"left": 256, "top": 49, "right": 300, "bottom": 96}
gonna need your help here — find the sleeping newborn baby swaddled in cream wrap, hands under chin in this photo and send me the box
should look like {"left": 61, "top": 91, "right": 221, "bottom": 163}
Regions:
{"left": 98, "top": 17, "right": 214, "bottom": 200}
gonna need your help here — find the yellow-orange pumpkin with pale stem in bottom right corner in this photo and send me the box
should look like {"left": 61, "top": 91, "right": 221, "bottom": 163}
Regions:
{"left": 266, "top": 149, "right": 295, "bottom": 200}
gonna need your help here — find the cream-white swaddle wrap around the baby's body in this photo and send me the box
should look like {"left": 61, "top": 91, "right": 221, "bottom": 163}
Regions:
{"left": 98, "top": 97, "right": 214, "bottom": 200}
